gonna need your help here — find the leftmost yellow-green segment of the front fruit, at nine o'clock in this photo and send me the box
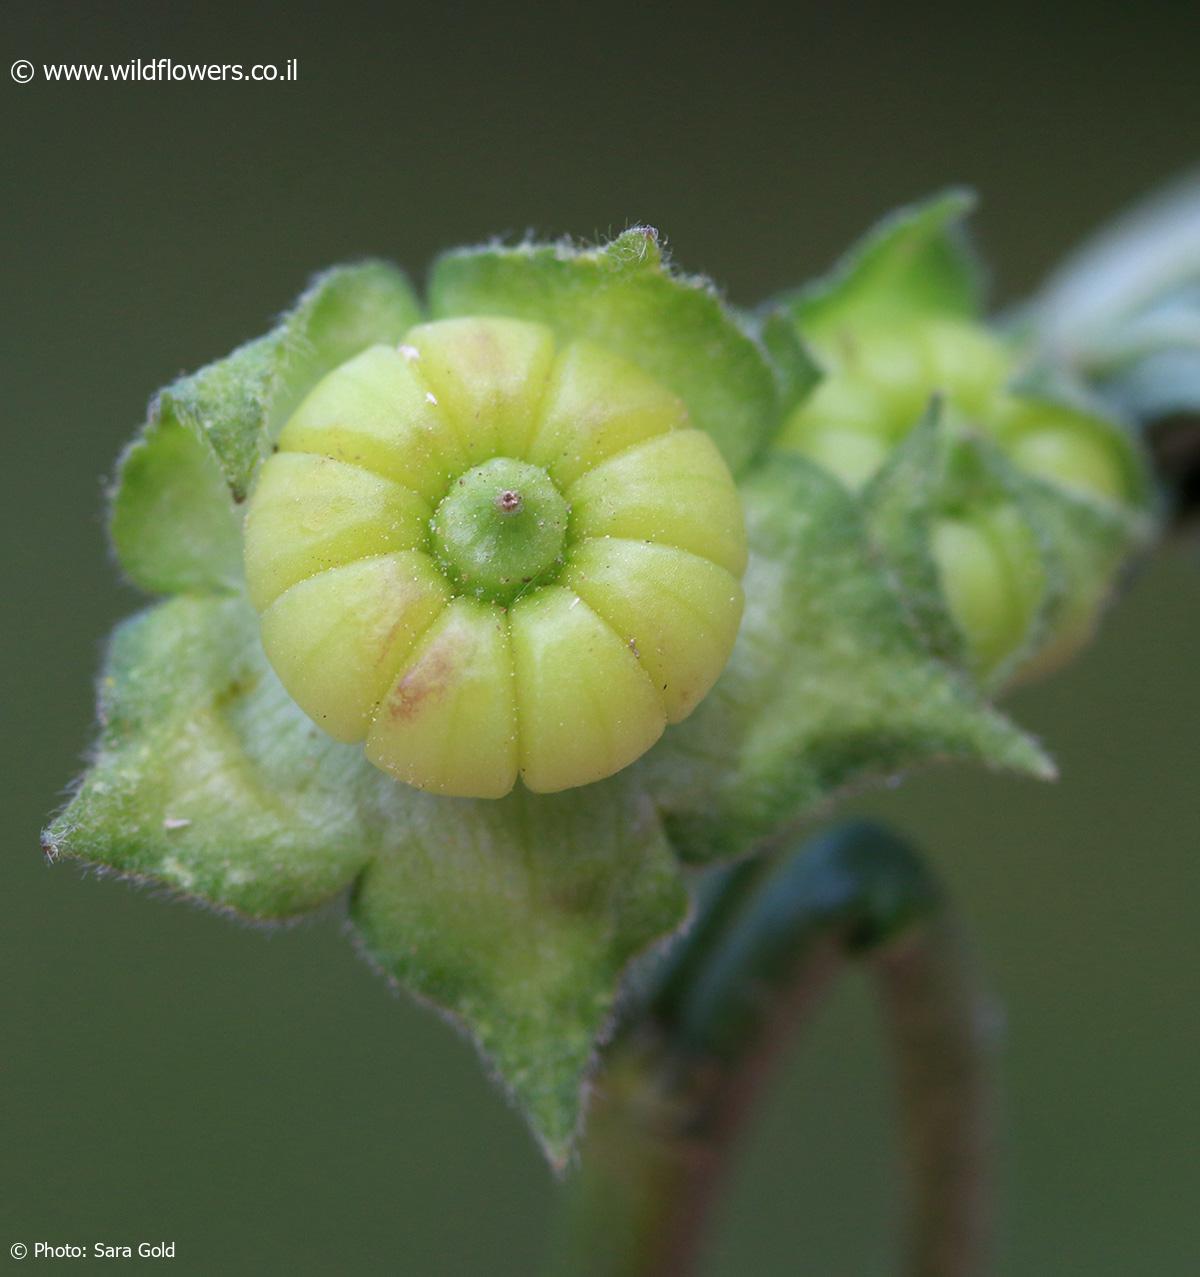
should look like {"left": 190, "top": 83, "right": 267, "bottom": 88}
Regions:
{"left": 245, "top": 452, "right": 431, "bottom": 610}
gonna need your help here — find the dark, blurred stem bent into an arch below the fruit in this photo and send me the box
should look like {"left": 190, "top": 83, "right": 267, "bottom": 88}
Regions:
{"left": 551, "top": 825, "right": 988, "bottom": 1277}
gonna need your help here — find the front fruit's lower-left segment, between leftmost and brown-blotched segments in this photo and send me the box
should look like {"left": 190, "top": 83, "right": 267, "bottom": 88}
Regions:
{"left": 262, "top": 550, "right": 451, "bottom": 741}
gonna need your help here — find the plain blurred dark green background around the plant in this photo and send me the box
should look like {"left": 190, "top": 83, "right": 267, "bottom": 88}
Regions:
{"left": 0, "top": 0, "right": 1200, "bottom": 1277}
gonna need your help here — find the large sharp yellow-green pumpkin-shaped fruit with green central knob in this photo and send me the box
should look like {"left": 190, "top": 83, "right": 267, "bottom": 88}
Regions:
{"left": 245, "top": 318, "right": 747, "bottom": 798}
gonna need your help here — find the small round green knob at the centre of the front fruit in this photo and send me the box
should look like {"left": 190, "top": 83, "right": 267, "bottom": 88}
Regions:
{"left": 431, "top": 457, "right": 569, "bottom": 603}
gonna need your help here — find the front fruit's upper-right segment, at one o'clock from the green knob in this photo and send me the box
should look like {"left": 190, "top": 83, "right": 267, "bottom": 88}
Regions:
{"left": 529, "top": 342, "right": 687, "bottom": 488}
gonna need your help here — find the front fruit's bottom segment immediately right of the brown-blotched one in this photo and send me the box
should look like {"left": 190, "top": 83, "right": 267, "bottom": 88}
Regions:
{"left": 509, "top": 586, "right": 666, "bottom": 793}
